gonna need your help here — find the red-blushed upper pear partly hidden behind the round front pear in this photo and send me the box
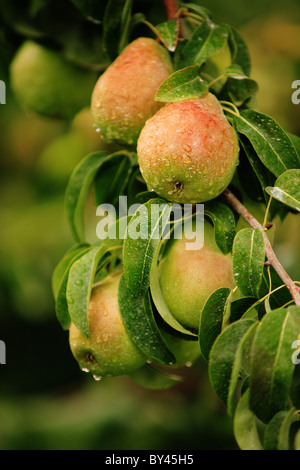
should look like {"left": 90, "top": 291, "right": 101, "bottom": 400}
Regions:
{"left": 91, "top": 37, "right": 173, "bottom": 146}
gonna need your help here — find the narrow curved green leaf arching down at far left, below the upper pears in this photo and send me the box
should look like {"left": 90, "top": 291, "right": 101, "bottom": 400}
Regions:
{"left": 65, "top": 152, "right": 109, "bottom": 242}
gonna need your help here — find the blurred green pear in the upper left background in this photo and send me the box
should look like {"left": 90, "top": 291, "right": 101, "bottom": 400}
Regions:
{"left": 10, "top": 40, "right": 97, "bottom": 120}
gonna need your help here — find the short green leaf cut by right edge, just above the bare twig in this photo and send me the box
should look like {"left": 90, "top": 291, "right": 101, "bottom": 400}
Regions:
{"left": 266, "top": 170, "right": 300, "bottom": 212}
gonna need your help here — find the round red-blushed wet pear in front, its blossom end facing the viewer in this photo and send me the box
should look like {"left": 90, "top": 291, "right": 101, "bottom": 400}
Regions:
{"left": 137, "top": 93, "right": 239, "bottom": 203}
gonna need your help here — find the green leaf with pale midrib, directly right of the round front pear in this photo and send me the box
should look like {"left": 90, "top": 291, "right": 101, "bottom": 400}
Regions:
{"left": 233, "top": 109, "right": 299, "bottom": 177}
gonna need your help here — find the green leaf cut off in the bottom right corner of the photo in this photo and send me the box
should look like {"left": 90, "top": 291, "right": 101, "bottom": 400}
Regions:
{"left": 264, "top": 408, "right": 300, "bottom": 450}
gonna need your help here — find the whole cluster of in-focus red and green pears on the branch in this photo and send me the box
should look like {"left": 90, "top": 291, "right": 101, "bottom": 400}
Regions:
{"left": 70, "top": 37, "right": 239, "bottom": 377}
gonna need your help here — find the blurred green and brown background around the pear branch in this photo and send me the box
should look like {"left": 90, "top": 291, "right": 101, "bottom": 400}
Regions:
{"left": 0, "top": 0, "right": 300, "bottom": 450}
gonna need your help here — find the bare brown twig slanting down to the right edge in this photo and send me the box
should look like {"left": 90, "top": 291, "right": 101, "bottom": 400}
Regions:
{"left": 223, "top": 189, "right": 300, "bottom": 306}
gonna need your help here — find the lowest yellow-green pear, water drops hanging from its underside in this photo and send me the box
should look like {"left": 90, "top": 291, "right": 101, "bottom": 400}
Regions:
{"left": 69, "top": 274, "right": 147, "bottom": 378}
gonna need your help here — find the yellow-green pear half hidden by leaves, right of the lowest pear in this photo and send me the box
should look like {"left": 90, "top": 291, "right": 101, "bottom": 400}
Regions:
{"left": 159, "top": 221, "right": 235, "bottom": 330}
